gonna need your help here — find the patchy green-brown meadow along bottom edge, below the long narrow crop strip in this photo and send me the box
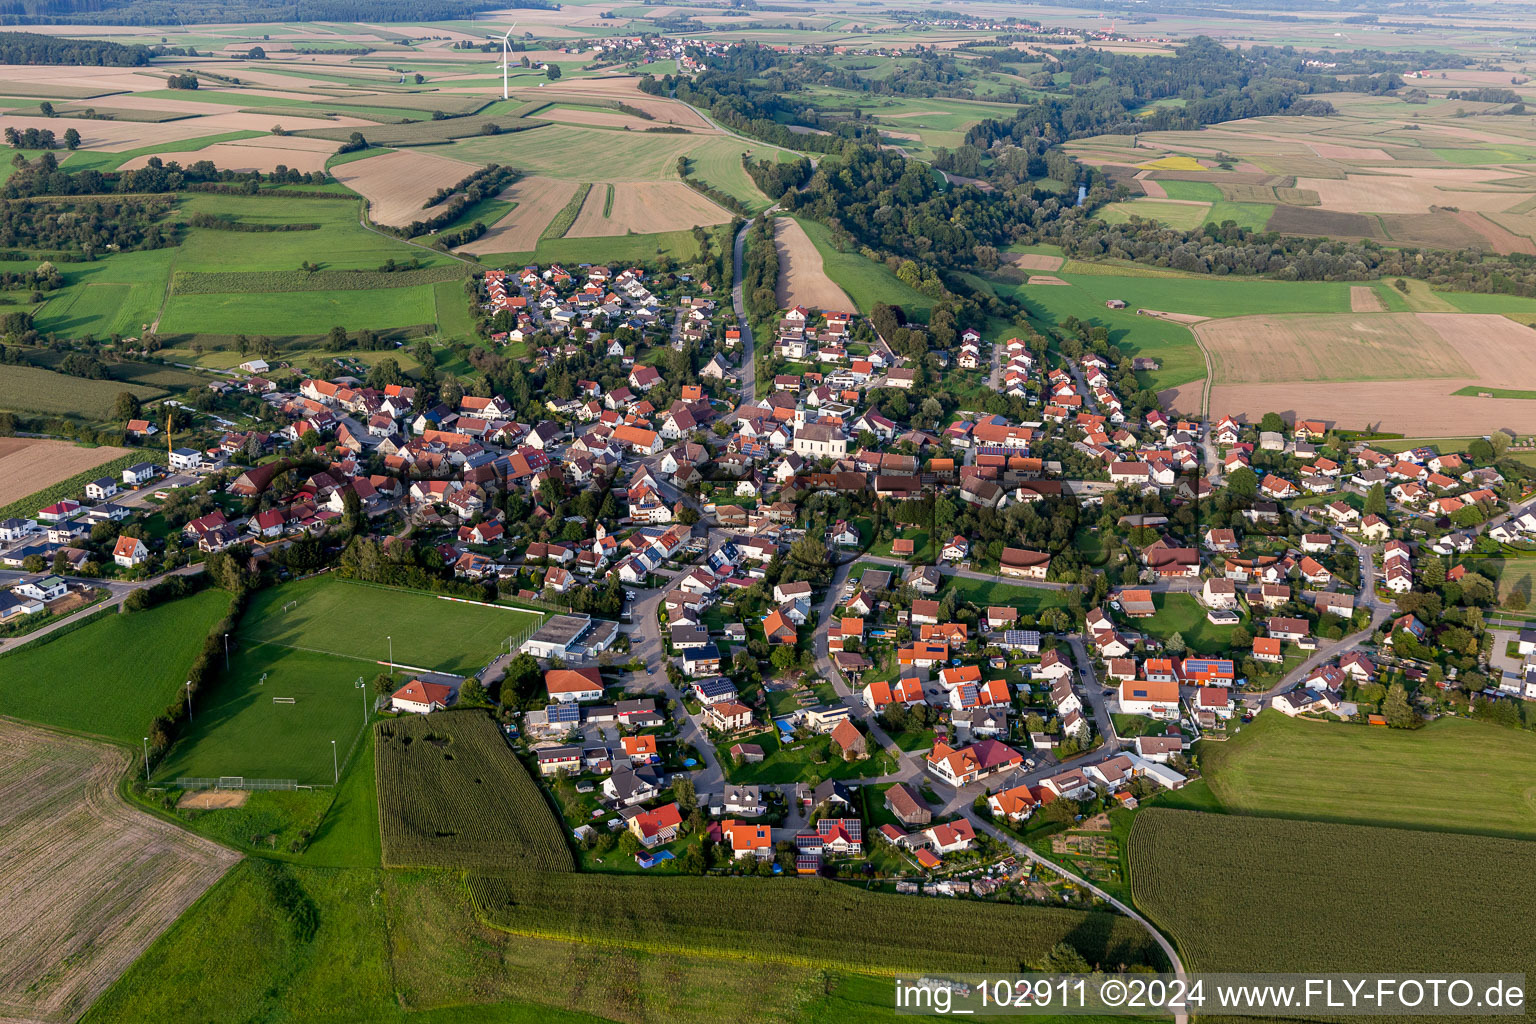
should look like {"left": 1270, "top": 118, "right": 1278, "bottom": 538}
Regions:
{"left": 84, "top": 858, "right": 891, "bottom": 1024}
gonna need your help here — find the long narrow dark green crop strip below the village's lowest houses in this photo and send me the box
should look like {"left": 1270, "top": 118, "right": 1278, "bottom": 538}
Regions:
{"left": 468, "top": 874, "right": 1161, "bottom": 975}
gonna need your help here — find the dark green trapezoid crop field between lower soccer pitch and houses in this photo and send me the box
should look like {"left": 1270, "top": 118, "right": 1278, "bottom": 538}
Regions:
{"left": 373, "top": 709, "right": 576, "bottom": 872}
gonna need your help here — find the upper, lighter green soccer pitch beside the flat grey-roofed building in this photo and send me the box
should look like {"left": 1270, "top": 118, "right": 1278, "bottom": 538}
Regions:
{"left": 230, "top": 576, "right": 542, "bottom": 677}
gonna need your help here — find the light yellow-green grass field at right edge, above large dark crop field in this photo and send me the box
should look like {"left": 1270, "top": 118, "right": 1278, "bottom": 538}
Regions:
{"left": 1201, "top": 712, "right": 1536, "bottom": 838}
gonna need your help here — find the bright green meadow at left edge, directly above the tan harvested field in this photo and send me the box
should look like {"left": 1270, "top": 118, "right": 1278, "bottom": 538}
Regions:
{"left": 0, "top": 590, "right": 230, "bottom": 749}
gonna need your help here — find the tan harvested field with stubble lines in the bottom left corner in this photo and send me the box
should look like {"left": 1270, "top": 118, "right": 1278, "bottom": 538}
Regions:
{"left": 0, "top": 722, "right": 240, "bottom": 1021}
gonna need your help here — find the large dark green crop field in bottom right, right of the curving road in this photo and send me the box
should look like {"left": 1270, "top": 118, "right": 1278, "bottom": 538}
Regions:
{"left": 1130, "top": 810, "right": 1536, "bottom": 972}
